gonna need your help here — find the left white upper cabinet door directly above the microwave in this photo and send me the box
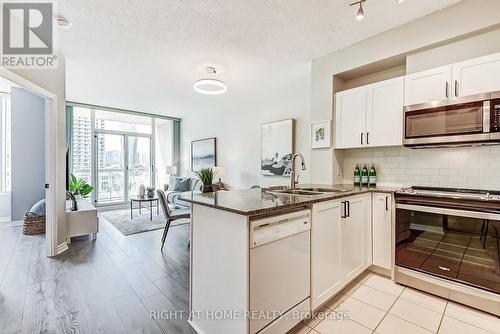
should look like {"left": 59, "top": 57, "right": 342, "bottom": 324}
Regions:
{"left": 404, "top": 65, "right": 452, "bottom": 106}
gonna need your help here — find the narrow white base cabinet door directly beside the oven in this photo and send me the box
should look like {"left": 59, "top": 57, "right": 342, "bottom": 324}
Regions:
{"left": 372, "top": 193, "right": 392, "bottom": 269}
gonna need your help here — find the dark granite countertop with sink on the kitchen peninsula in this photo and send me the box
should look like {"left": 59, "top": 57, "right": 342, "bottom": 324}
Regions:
{"left": 179, "top": 184, "right": 401, "bottom": 216}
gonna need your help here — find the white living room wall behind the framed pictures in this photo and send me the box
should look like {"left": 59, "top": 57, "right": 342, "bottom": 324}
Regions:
{"left": 179, "top": 65, "right": 310, "bottom": 189}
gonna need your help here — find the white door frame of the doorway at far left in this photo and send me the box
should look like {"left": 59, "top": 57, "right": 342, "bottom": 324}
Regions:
{"left": 0, "top": 67, "right": 59, "bottom": 257}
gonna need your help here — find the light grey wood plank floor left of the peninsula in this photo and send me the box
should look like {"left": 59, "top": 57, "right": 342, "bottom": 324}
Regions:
{"left": 0, "top": 215, "right": 195, "bottom": 334}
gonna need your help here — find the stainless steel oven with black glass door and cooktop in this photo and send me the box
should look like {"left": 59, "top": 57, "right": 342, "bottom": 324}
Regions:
{"left": 395, "top": 187, "right": 500, "bottom": 315}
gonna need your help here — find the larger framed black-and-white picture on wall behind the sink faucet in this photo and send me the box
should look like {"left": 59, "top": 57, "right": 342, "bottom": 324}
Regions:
{"left": 260, "top": 118, "right": 294, "bottom": 176}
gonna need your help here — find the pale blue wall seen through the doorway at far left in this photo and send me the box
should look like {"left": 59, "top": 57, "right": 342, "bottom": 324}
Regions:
{"left": 10, "top": 87, "right": 45, "bottom": 220}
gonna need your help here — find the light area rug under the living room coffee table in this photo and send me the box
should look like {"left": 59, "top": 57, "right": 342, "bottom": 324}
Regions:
{"left": 99, "top": 208, "right": 189, "bottom": 235}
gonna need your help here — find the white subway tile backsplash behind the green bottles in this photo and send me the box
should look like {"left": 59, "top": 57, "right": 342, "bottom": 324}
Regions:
{"left": 343, "top": 146, "right": 500, "bottom": 190}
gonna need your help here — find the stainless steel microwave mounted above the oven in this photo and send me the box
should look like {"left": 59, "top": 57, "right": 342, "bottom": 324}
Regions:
{"left": 403, "top": 92, "right": 500, "bottom": 147}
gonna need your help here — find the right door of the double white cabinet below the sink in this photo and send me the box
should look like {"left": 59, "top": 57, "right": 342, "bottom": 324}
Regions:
{"left": 340, "top": 196, "right": 366, "bottom": 281}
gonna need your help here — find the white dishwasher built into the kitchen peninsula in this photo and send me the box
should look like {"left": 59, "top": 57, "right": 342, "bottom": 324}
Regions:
{"left": 250, "top": 210, "right": 311, "bottom": 334}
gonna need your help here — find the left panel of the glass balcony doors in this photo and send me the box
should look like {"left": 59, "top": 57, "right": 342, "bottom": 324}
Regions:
{"left": 95, "top": 133, "right": 126, "bottom": 204}
